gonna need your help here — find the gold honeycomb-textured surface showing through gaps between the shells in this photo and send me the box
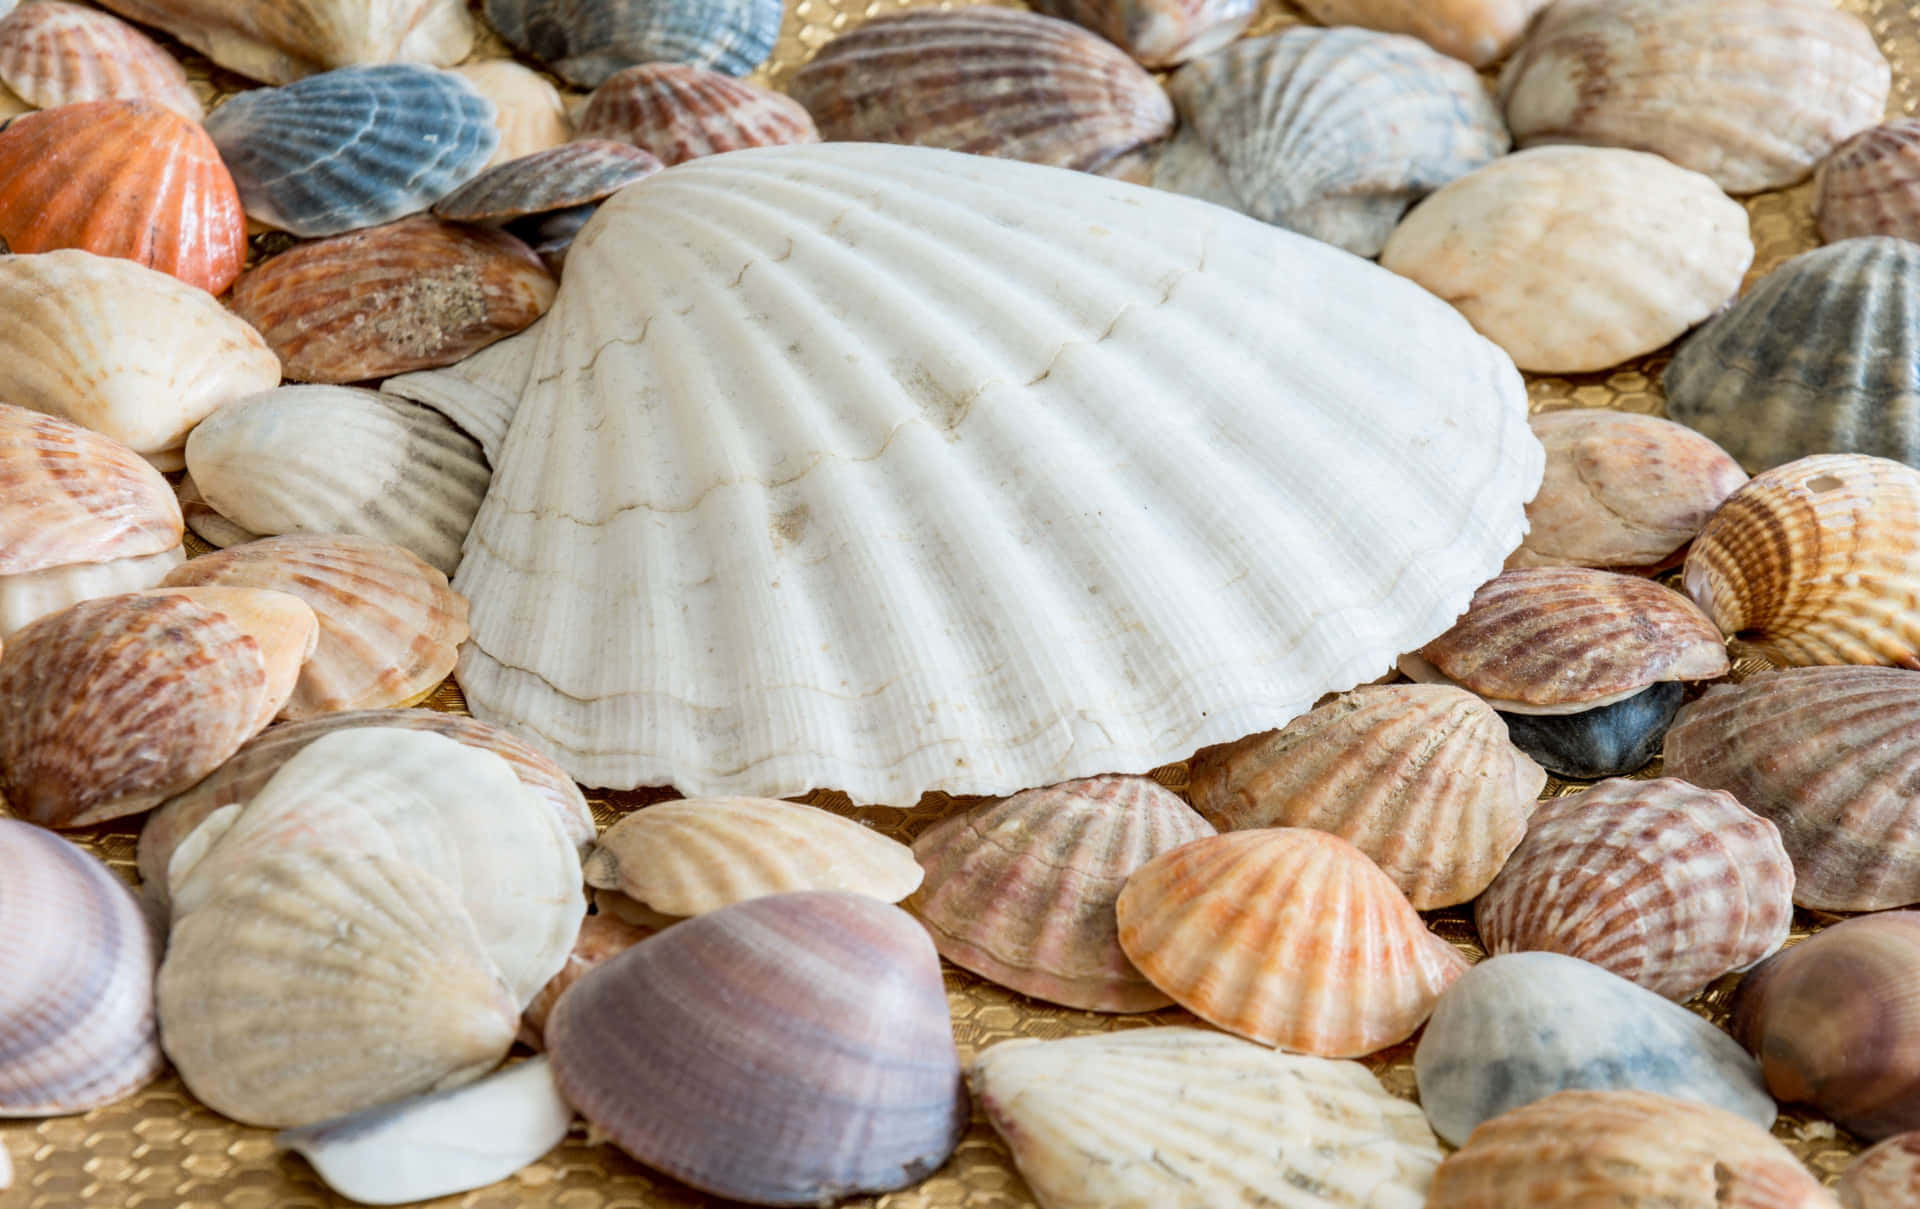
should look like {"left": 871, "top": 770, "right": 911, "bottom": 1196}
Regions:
{"left": 0, "top": 0, "right": 1920, "bottom": 1209}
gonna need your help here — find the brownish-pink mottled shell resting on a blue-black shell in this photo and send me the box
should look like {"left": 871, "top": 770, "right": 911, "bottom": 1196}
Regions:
{"left": 1421, "top": 566, "right": 1728, "bottom": 712}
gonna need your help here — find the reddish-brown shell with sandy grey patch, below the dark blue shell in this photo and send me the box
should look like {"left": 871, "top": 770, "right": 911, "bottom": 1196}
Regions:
{"left": 227, "top": 215, "right": 555, "bottom": 383}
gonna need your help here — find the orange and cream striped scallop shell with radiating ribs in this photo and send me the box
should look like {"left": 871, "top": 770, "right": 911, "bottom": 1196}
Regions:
{"left": 1116, "top": 827, "right": 1467, "bottom": 1057}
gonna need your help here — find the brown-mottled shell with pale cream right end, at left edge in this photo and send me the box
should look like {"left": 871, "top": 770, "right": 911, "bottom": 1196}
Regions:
{"left": 0, "top": 587, "right": 315, "bottom": 827}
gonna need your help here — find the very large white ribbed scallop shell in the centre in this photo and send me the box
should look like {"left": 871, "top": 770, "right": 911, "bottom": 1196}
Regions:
{"left": 405, "top": 144, "right": 1542, "bottom": 802}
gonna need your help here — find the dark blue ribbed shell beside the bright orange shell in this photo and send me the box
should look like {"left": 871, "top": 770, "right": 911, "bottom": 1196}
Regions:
{"left": 205, "top": 63, "right": 499, "bottom": 238}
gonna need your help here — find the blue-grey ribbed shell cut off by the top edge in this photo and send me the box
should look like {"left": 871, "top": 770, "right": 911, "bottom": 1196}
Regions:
{"left": 486, "top": 0, "right": 783, "bottom": 88}
